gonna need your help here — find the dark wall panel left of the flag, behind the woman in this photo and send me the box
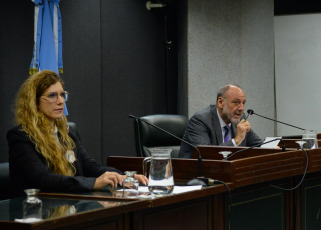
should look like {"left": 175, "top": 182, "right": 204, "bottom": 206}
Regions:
{"left": 0, "top": 0, "right": 34, "bottom": 162}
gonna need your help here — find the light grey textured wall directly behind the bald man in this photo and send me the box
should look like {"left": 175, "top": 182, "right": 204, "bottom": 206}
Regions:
{"left": 180, "top": 0, "right": 275, "bottom": 138}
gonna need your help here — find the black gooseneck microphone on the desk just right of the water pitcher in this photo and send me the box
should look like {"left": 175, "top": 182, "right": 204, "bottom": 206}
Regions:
{"left": 128, "top": 114, "right": 209, "bottom": 185}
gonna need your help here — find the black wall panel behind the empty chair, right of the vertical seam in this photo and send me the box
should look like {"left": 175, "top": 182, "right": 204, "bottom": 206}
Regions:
{"left": 101, "top": 0, "right": 176, "bottom": 159}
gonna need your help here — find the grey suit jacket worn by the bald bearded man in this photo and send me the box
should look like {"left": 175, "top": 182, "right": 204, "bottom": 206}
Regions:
{"left": 178, "top": 105, "right": 263, "bottom": 158}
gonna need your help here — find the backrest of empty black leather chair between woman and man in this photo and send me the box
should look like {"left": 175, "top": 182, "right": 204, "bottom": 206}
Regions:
{"left": 134, "top": 114, "right": 188, "bottom": 158}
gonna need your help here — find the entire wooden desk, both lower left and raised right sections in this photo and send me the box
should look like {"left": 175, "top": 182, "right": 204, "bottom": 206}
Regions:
{"left": 0, "top": 149, "right": 321, "bottom": 230}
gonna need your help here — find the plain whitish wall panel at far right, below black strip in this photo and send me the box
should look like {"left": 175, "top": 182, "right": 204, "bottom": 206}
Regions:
{"left": 275, "top": 14, "right": 321, "bottom": 135}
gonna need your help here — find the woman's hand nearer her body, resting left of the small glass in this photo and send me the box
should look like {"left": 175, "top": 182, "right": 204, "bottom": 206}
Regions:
{"left": 94, "top": 172, "right": 126, "bottom": 190}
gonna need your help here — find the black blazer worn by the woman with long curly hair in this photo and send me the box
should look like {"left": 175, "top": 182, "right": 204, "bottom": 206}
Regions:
{"left": 7, "top": 126, "right": 122, "bottom": 196}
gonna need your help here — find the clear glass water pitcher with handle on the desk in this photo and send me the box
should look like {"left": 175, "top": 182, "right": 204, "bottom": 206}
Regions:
{"left": 143, "top": 148, "right": 174, "bottom": 195}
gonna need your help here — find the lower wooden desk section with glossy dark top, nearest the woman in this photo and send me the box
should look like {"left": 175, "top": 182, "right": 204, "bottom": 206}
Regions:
{"left": 0, "top": 185, "right": 226, "bottom": 230}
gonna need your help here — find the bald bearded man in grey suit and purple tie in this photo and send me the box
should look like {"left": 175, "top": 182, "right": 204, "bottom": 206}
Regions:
{"left": 178, "top": 85, "right": 263, "bottom": 158}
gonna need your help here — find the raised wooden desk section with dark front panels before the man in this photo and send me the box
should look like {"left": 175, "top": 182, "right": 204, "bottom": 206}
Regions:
{"left": 108, "top": 147, "right": 321, "bottom": 230}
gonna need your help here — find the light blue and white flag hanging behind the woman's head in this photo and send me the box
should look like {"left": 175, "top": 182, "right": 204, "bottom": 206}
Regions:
{"left": 29, "top": 0, "right": 68, "bottom": 116}
